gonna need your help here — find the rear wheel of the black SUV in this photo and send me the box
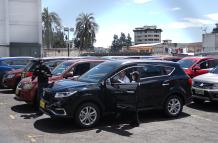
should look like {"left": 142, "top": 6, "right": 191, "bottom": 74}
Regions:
{"left": 164, "top": 95, "right": 183, "bottom": 117}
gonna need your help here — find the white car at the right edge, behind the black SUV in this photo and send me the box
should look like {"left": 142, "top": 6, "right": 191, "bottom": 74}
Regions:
{"left": 192, "top": 66, "right": 218, "bottom": 103}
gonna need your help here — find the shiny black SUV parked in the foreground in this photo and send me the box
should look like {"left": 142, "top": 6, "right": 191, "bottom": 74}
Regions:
{"left": 40, "top": 60, "right": 191, "bottom": 128}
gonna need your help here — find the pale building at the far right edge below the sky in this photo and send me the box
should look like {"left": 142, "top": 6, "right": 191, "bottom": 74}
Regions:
{"left": 202, "top": 24, "right": 218, "bottom": 53}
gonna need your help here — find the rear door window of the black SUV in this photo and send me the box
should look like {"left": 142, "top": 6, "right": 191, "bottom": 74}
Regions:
{"left": 140, "top": 65, "right": 164, "bottom": 78}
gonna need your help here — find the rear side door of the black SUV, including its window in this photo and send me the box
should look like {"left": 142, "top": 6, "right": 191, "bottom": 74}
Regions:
{"left": 139, "top": 64, "right": 173, "bottom": 108}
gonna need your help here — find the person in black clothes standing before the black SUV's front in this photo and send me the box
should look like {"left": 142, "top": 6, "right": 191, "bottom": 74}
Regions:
{"left": 32, "top": 60, "right": 52, "bottom": 107}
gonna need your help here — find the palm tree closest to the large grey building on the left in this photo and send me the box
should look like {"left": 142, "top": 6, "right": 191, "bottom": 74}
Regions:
{"left": 42, "top": 8, "right": 61, "bottom": 48}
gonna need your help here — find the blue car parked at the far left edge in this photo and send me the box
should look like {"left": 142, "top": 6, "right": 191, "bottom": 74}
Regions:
{"left": 0, "top": 57, "right": 33, "bottom": 87}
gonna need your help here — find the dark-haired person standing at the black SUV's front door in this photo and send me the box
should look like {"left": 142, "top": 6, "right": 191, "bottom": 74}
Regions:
{"left": 130, "top": 71, "right": 140, "bottom": 127}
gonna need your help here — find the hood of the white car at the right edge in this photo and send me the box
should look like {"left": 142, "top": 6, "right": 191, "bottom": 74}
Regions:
{"left": 193, "top": 73, "right": 218, "bottom": 83}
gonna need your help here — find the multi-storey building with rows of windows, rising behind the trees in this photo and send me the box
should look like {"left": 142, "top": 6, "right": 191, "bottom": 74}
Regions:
{"left": 133, "top": 26, "right": 162, "bottom": 45}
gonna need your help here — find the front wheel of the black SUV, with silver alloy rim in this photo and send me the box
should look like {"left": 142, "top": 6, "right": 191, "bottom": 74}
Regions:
{"left": 74, "top": 103, "right": 100, "bottom": 128}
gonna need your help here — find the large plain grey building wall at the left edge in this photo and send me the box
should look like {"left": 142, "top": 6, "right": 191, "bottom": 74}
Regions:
{"left": 0, "top": 0, "right": 42, "bottom": 57}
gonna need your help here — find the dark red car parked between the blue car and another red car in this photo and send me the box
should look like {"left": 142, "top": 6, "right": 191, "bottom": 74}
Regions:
{"left": 2, "top": 57, "right": 72, "bottom": 90}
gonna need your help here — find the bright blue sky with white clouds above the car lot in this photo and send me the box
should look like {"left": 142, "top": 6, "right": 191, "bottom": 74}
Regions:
{"left": 42, "top": 0, "right": 218, "bottom": 48}
